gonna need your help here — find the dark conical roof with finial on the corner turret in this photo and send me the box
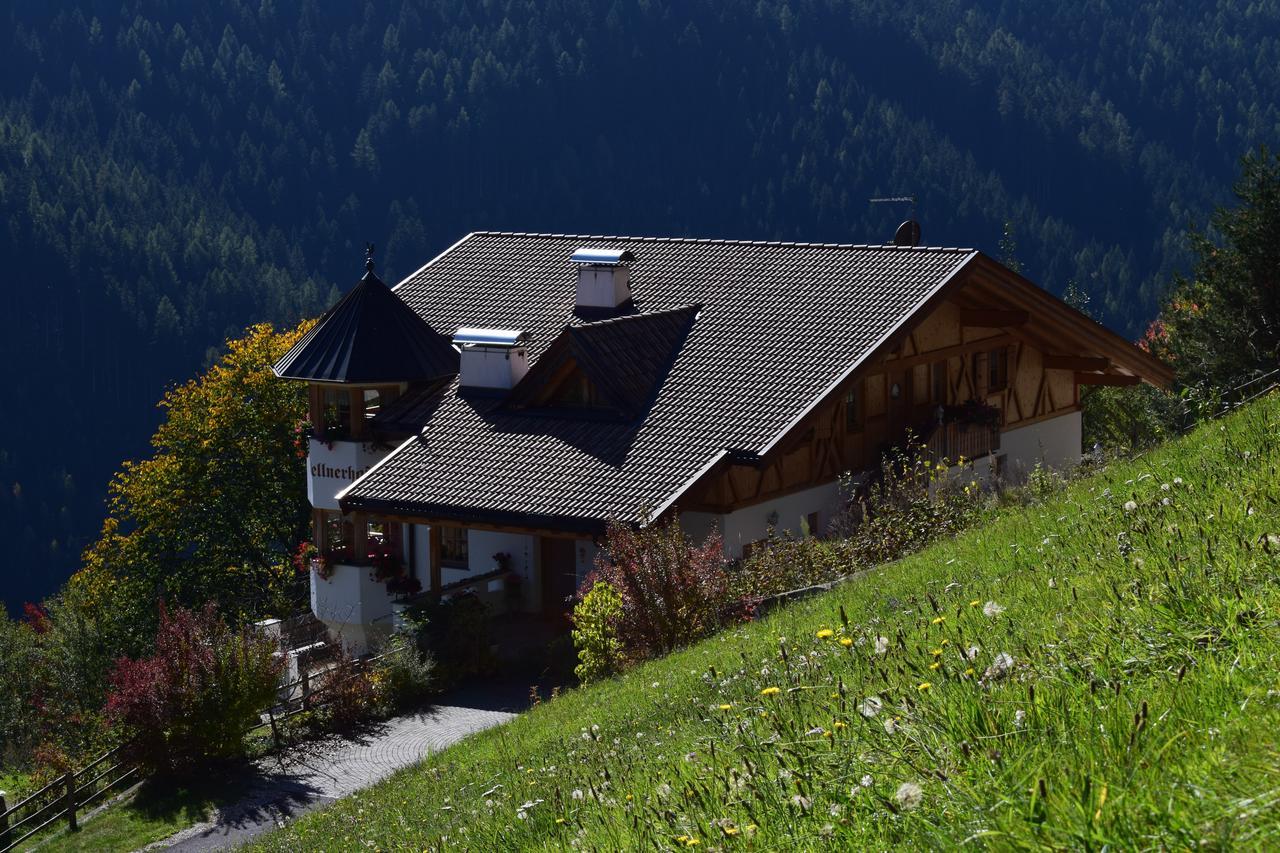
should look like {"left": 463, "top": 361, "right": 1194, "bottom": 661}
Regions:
{"left": 274, "top": 246, "right": 458, "bottom": 386}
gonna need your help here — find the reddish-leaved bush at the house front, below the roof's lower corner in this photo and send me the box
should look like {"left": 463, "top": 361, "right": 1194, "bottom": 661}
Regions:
{"left": 581, "top": 521, "right": 728, "bottom": 661}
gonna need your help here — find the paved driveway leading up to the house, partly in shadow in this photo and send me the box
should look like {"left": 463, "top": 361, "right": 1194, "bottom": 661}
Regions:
{"left": 147, "top": 683, "right": 529, "bottom": 853}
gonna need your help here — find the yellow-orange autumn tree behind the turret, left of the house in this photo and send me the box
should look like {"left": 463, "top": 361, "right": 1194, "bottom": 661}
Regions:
{"left": 80, "top": 323, "right": 310, "bottom": 637}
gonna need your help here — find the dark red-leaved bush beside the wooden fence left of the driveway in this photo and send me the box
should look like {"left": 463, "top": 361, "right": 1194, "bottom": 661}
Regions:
{"left": 106, "top": 603, "right": 283, "bottom": 774}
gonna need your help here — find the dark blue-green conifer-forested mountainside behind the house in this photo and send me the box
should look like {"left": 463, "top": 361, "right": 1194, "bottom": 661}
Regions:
{"left": 0, "top": 0, "right": 1280, "bottom": 606}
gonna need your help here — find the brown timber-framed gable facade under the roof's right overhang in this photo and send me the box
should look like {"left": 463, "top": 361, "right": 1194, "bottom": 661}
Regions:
{"left": 678, "top": 268, "right": 1111, "bottom": 514}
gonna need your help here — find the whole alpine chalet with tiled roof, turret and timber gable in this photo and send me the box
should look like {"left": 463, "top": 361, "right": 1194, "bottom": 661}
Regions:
{"left": 275, "top": 233, "right": 1171, "bottom": 651}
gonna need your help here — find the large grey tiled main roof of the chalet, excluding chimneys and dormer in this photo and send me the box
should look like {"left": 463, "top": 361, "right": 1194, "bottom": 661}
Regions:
{"left": 343, "top": 233, "right": 975, "bottom": 529}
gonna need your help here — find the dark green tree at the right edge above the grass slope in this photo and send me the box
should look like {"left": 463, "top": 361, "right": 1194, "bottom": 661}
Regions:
{"left": 1167, "top": 147, "right": 1280, "bottom": 389}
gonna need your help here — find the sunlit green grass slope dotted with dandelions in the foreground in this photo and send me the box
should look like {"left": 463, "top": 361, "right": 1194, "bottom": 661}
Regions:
{"left": 249, "top": 396, "right": 1280, "bottom": 850}
